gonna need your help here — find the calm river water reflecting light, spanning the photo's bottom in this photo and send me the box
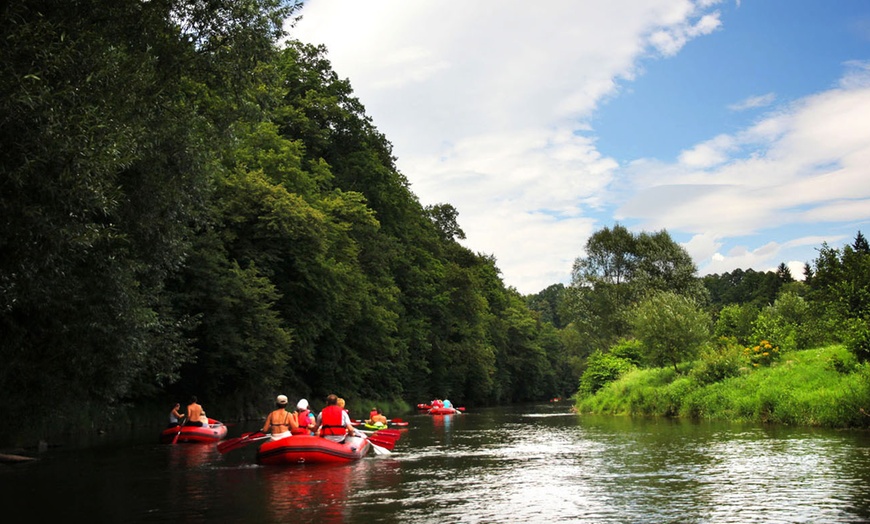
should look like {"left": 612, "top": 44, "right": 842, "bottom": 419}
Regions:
{"left": 0, "top": 403, "right": 870, "bottom": 524}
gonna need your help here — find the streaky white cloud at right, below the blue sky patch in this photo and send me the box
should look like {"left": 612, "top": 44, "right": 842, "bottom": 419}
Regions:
{"left": 615, "top": 73, "right": 870, "bottom": 276}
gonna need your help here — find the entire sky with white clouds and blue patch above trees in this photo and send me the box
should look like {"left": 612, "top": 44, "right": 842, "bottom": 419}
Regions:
{"left": 289, "top": 0, "right": 870, "bottom": 294}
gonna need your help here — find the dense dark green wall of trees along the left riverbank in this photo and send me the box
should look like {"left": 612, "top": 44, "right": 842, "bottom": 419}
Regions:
{"left": 0, "top": 0, "right": 579, "bottom": 442}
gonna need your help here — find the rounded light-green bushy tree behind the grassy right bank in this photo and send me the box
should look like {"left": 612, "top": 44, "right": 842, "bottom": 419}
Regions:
{"left": 631, "top": 291, "right": 711, "bottom": 371}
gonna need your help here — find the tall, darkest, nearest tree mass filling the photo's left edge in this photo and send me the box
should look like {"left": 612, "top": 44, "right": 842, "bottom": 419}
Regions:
{"left": 0, "top": 0, "right": 300, "bottom": 430}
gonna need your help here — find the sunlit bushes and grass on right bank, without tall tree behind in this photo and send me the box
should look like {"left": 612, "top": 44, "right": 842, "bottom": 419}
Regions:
{"left": 560, "top": 232, "right": 870, "bottom": 426}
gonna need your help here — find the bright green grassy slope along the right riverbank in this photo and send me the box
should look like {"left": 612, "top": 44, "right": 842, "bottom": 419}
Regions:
{"left": 576, "top": 346, "right": 870, "bottom": 428}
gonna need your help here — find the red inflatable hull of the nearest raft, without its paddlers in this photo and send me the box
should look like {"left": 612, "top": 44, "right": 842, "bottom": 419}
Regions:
{"left": 257, "top": 435, "right": 371, "bottom": 464}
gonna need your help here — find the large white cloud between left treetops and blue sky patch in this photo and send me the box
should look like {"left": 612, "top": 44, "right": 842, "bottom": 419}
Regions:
{"left": 292, "top": 0, "right": 721, "bottom": 293}
